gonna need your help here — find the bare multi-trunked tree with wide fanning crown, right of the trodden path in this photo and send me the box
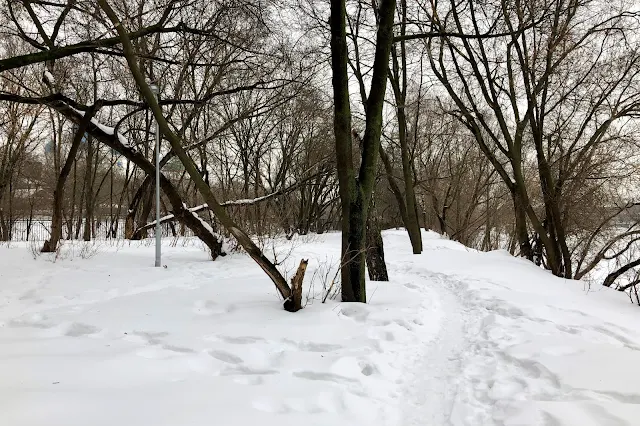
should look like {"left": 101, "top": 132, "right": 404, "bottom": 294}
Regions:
{"left": 427, "top": 0, "right": 640, "bottom": 278}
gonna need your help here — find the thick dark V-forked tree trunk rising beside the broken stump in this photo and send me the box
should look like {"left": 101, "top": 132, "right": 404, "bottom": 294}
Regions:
{"left": 330, "top": 0, "right": 395, "bottom": 303}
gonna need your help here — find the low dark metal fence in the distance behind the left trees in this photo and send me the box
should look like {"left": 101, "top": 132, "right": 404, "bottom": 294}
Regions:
{"left": 9, "top": 218, "right": 193, "bottom": 241}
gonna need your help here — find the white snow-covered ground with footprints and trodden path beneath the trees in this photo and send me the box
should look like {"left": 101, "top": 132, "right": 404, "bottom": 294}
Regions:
{"left": 0, "top": 231, "right": 640, "bottom": 426}
